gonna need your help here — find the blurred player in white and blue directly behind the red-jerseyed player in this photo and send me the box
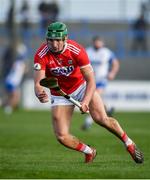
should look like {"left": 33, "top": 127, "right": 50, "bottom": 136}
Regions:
{"left": 81, "top": 36, "right": 119, "bottom": 130}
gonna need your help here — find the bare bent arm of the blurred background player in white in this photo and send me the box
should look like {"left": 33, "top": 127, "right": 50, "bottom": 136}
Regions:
{"left": 108, "top": 58, "right": 120, "bottom": 80}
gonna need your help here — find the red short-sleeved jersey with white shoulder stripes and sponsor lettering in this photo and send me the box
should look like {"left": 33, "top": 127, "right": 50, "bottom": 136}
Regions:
{"left": 34, "top": 40, "right": 90, "bottom": 96}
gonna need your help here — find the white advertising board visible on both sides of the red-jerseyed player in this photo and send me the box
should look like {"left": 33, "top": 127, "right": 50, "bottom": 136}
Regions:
{"left": 22, "top": 79, "right": 150, "bottom": 111}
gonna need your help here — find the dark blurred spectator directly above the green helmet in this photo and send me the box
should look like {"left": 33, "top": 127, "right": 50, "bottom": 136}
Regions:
{"left": 38, "top": 0, "right": 59, "bottom": 35}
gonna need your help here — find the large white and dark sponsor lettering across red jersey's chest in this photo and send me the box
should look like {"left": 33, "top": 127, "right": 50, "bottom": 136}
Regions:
{"left": 50, "top": 66, "right": 74, "bottom": 76}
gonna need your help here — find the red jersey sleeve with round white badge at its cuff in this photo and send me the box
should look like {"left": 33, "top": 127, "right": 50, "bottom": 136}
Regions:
{"left": 34, "top": 54, "right": 46, "bottom": 70}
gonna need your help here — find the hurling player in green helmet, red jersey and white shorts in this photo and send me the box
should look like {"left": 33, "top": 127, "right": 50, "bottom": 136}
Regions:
{"left": 34, "top": 22, "right": 143, "bottom": 163}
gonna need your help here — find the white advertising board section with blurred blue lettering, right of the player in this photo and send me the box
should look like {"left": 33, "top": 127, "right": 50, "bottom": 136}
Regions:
{"left": 103, "top": 81, "right": 150, "bottom": 111}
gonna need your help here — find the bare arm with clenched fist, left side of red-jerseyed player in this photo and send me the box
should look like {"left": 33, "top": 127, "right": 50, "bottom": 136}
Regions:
{"left": 34, "top": 70, "right": 49, "bottom": 103}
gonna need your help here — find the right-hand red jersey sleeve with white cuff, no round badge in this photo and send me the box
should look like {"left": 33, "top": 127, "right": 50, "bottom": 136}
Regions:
{"left": 77, "top": 47, "right": 90, "bottom": 68}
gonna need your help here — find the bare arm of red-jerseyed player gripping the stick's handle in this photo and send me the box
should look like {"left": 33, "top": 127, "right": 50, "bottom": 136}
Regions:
{"left": 80, "top": 64, "right": 96, "bottom": 112}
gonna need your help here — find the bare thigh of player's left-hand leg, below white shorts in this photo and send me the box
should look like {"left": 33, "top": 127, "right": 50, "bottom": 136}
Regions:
{"left": 52, "top": 105, "right": 74, "bottom": 135}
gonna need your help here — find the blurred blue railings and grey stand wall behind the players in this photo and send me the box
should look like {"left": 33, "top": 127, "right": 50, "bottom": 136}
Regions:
{"left": 0, "top": 24, "right": 150, "bottom": 80}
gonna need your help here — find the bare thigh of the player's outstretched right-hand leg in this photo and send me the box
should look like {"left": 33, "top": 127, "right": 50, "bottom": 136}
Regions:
{"left": 89, "top": 91, "right": 107, "bottom": 122}
